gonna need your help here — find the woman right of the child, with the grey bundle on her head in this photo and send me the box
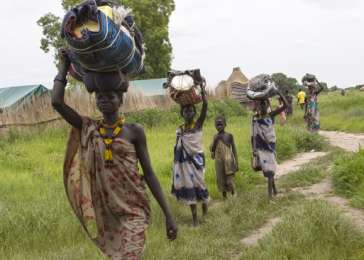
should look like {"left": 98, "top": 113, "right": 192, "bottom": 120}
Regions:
{"left": 247, "top": 74, "right": 287, "bottom": 199}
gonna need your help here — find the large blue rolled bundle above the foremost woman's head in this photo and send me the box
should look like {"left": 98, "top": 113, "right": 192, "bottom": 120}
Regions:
{"left": 61, "top": 0, "right": 144, "bottom": 83}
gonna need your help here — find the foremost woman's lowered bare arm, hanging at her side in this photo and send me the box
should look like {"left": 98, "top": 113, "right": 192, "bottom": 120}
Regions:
{"left": 133, "top": 126, "right": 177, "bottom": 240}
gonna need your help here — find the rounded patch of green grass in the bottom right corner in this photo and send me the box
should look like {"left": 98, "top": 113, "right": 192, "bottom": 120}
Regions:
{"left": 241, "top": 201, "right": 364, "bottom": 260}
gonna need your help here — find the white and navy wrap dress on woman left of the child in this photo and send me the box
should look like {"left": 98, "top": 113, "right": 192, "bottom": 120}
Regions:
{"left": 172, "top": 128, "right": 209, "bottom": 205}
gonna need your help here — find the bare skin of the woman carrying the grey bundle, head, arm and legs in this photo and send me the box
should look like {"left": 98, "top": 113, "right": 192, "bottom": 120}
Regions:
{"left": 255, "top": 90, "right": 288, "bottom": 199}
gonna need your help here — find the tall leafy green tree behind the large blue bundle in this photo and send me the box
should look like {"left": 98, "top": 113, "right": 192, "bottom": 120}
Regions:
{"left": 37, "top": 0, "right": 175, "bottom": 78}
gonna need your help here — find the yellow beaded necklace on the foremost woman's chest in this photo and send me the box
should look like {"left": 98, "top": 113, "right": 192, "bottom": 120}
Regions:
{"left": 99, "top": 117, "right": 125, "bottom": 164}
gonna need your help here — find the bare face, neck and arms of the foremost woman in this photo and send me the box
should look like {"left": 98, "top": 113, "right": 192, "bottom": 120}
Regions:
{"left": 52, "top": 51, "right": 177, "bottom": 240}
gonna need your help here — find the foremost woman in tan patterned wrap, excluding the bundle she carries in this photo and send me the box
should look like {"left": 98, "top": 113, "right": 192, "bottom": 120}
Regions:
{"left": 52, "top": 53, "right": 177, "bottom": 260}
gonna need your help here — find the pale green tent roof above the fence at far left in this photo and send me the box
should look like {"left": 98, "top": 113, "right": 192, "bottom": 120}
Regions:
{"left": 0, "top": 85, "right": 49, "bottom": 110}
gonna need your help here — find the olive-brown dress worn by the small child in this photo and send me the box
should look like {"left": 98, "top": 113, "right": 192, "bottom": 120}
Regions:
{"left": 215, "top": 140, "right": 237, "bottom": 192}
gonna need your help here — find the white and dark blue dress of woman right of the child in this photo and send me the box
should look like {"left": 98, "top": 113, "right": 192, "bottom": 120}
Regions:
{"left": 252, "top": 115, "right": 277, "bottom": 175}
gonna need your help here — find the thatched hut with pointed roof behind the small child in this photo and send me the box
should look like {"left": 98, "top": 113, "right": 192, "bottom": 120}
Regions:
{"left": 215, "top": 67, "right": 249, "bottom": 103}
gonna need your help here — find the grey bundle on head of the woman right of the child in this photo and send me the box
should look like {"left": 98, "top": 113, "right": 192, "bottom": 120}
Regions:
{"left": 247, "top": 74, "right": 277, "bottom": 100}
